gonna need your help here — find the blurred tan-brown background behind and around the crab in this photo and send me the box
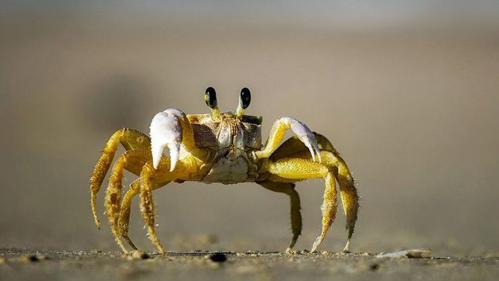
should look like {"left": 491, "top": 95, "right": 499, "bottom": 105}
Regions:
{"left": 0, "top": 0, "right": 499, "bottom": 255}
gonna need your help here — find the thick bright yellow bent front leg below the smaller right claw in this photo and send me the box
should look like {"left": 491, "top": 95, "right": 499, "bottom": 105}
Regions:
{"left": 267, "top": 158, "right": 337, "bottom": 251}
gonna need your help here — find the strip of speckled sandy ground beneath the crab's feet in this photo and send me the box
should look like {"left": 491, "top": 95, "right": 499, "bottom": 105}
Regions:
{"left": 0, "top": 249, "right": 499, "bottom": 280}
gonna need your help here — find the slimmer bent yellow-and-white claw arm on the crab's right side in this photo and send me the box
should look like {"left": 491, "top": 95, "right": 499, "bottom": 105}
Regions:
{"left": 255, "top": 117, "right": 321, "bottom": 162}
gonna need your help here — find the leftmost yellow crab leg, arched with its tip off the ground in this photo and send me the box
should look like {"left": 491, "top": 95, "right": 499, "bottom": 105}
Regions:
{"left": 90, "top": 128, "right": 151, "bottom": 228}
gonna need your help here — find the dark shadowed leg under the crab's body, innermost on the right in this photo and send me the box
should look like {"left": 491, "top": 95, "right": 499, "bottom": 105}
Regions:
{"left": 258, "top": 181, "right": 302, "bottom": 253}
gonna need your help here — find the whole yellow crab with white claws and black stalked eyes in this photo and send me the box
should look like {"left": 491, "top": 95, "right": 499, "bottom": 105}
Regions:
{"left": 90, "top": 87, "right": 359, "bottom": 254}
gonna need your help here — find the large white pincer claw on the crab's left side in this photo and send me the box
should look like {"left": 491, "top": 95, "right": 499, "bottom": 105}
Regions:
{"left": 150, "top": 108, "right": 185, "bottom": 172}
